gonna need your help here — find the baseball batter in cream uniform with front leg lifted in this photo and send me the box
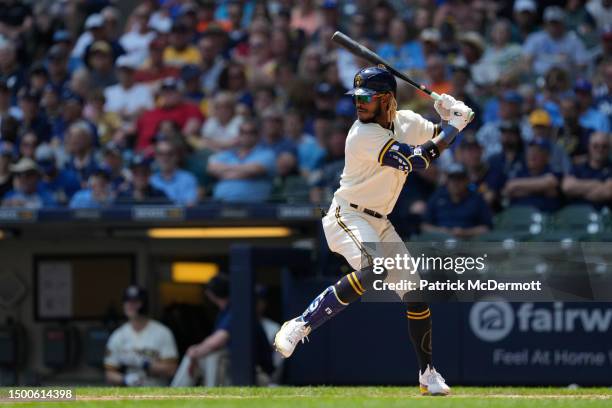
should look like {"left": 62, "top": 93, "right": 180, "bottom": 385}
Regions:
{"left": 274, "top": 67, "right": 471, "bottom": 395}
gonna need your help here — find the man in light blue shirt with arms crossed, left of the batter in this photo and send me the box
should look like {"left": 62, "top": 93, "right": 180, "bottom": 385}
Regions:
{"left": 208, "top": 119, "right": 276, "bottom": 202}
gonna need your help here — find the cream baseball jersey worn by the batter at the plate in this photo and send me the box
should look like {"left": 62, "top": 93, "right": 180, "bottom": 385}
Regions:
{"left": 335, "top": 110, "right": 435, "bottom": 215}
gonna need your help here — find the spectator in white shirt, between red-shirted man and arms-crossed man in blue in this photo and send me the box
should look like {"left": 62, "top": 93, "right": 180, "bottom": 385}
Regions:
{"left": 195, "top": 92, "right": 243, "bottom": 151}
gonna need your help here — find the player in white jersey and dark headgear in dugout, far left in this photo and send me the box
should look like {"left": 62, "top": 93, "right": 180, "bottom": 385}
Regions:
{"left": 104, "top": 286, "right": 178, "bottom": 386}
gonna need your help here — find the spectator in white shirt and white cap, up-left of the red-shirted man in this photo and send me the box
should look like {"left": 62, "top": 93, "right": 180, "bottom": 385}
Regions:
{"left": 104, "top": 55, "right": 154, "bottom": 119}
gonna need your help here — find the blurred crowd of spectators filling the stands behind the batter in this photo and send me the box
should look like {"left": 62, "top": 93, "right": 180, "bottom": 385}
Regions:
{"left": 0, "top": 0, "right": 612, "bottom": 235}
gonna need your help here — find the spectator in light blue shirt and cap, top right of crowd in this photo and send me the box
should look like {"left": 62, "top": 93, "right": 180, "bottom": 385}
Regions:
{"left": 523, "top": 6, "right": 589, "bottom": 76}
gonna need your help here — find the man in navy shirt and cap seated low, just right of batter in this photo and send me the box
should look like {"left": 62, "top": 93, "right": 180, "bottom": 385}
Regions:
{"left": 421, "top": 163, "right": 492, "bottom": 238}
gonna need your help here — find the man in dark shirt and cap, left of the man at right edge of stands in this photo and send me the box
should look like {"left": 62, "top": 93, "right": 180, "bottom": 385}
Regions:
{"left": 502, "top": 138, "right": 562, "bottom": 212}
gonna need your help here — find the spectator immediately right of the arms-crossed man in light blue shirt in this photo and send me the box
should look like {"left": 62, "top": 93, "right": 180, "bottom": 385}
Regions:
{"left": 260, "top": 108, "right": 297, "bottom": 177}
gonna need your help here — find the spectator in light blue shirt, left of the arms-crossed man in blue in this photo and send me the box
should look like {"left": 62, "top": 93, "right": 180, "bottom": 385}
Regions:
{"left": 151, "top": 139, "right": 198, "bottom": 206}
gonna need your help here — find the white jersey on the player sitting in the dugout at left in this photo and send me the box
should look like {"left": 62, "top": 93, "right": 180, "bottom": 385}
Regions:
{"left": 104, "top": 319, "right": 178, "bottom": 386}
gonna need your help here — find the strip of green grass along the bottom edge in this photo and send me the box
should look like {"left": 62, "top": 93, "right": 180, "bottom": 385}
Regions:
{"left": 0, "top": 386, "right": 612, "bottom": 408}
